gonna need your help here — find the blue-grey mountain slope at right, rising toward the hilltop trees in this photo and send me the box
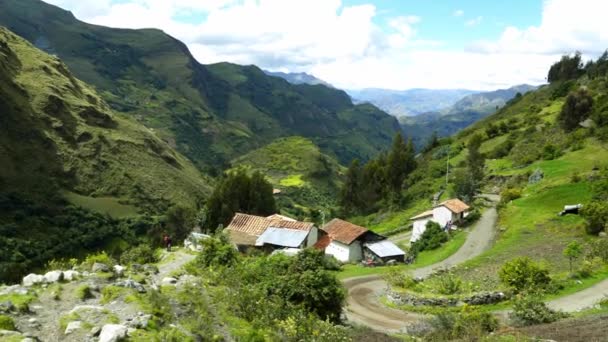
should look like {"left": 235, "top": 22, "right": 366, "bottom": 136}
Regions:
{"left": 400, "top": 84, "right": 537, "bottom": 147}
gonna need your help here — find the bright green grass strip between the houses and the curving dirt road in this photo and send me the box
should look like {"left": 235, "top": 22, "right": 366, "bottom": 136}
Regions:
{"left": 337, "top": 232, "right": 467, "bottom": 279}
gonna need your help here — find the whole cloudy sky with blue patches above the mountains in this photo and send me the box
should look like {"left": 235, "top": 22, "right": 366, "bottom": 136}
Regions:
{"left": 45, "top": 0, "right": 608, "bottom": 90}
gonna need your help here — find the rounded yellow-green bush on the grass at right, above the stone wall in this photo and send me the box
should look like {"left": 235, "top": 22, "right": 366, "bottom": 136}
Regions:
{"left": 498, "top": 257, "right": 551, "bottom": 292}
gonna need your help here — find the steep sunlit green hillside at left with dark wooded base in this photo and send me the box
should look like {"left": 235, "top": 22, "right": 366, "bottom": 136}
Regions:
{"left": 0, "top": 27, "right": 211, "bottom": 281}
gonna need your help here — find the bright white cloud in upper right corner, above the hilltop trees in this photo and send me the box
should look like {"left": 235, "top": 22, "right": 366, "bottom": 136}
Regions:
{"left": 470, "top": 0, "right": 608, "bottom": 55}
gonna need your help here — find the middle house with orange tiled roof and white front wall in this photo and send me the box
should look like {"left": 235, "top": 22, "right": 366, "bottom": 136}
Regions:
{"left": 315, "top": 219, "right": 384, "bottom": 262}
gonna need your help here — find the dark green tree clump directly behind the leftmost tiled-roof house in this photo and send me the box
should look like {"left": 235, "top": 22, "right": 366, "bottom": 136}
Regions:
{"left": 206, "top": 170, "right": 277, "bottom": 231}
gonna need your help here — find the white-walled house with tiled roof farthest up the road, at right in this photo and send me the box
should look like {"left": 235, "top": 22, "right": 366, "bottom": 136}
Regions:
{"left": 410, "top": 198, "right": 470, "bottom": 242}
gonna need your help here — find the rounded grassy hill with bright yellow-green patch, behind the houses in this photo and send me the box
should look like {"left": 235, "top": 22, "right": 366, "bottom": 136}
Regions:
{"left": 232, "top": 137, "right": 344, "bottom": 216}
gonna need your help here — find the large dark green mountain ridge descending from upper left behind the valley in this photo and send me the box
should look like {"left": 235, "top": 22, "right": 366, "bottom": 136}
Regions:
{"left": 0, "top": 0, "right": 399, "bottom": 168}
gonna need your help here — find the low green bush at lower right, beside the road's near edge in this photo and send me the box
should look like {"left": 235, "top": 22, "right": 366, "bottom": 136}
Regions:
{"left": 511, "top": 295, "right": 567, "bottom": 325}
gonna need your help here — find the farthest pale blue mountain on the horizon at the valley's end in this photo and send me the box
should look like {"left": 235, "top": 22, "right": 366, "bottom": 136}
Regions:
{"left": 347, "top": 88, "right": 477, "bottom": 117}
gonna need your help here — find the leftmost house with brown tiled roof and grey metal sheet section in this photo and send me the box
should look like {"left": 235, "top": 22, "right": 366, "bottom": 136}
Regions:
{"left": 225, "top": 213, "right": 318, "bottom": 250}
